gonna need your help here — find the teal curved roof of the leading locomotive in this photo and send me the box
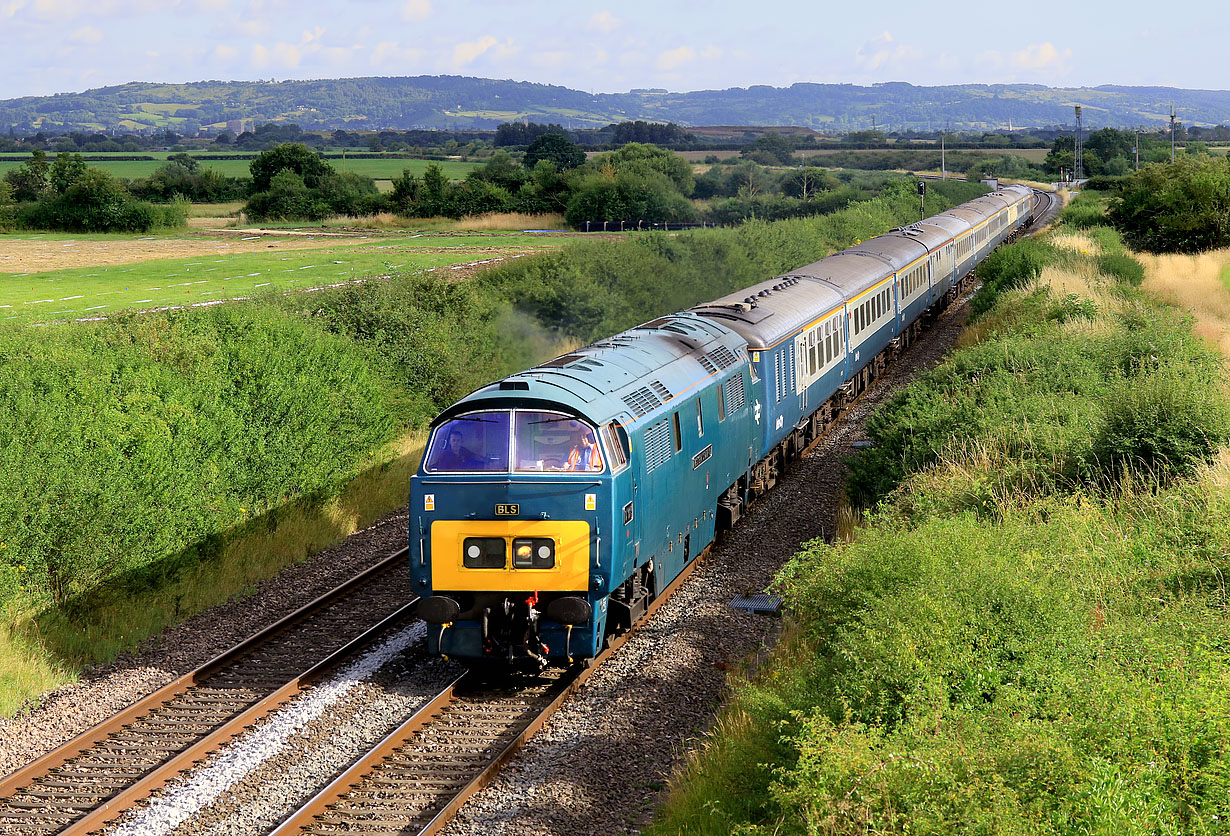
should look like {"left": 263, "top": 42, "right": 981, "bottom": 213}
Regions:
{"left": 435, "top": 311, "right": 747, "bottom": 427}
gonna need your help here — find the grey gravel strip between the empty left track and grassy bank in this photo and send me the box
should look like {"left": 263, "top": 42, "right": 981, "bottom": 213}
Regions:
{"left": 0, "top": 509, "right": 406, "bottom": 775}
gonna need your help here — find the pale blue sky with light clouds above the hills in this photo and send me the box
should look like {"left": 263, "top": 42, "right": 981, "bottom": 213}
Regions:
{"left": 0, "top": 0, "right": 1230, "bottom": 98}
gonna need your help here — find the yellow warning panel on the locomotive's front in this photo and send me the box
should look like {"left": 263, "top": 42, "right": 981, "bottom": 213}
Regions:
{"left": 431, "top": 520, "right": 590, "bottom": 593}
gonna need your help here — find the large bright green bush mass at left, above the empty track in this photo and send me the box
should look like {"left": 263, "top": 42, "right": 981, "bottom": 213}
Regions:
{"left": 0, "top": 305, "right": 399, "bottom": 601}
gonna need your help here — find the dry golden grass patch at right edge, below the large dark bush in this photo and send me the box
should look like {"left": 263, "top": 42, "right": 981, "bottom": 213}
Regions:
{"left": 1138, "top": 244, "right": 1230, "bottom": 357}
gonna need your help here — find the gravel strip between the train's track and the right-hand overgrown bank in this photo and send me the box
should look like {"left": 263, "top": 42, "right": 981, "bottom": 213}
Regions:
{"left": 442, "top": 296, "right": 968, "bottom": 836}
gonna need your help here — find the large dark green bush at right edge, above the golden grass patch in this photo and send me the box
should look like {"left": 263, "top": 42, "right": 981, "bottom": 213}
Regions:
{"left": 1109, "top": 157, "right": 1230, "bottom": 252}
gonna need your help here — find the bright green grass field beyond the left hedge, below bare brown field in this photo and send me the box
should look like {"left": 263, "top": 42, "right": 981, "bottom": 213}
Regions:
{"left": 0, "top": 234, "right": 569, "bottom": 322}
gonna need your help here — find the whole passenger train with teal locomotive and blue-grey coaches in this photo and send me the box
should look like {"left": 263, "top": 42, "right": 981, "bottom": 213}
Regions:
{"left": 410, "top": 186, "right": 1034, "bottom": 671}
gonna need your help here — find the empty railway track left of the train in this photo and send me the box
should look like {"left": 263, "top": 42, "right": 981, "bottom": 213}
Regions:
{"left": 0, "top": 550, "right": 415, "bottom": 836}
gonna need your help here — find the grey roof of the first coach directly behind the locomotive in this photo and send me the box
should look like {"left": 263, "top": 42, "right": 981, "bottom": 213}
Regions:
{"left": 691, "top": 267, "right": 843, "bottom": 349}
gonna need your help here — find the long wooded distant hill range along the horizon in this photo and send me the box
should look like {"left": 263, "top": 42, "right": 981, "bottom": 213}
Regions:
{"left": 7, "top": 76, "right": 1230, "bottom": 133}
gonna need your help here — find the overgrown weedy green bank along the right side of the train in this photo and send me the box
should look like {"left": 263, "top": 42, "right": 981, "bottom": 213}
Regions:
{"left": 652, "top": 212, "right": 1230, "bottom": 836}
